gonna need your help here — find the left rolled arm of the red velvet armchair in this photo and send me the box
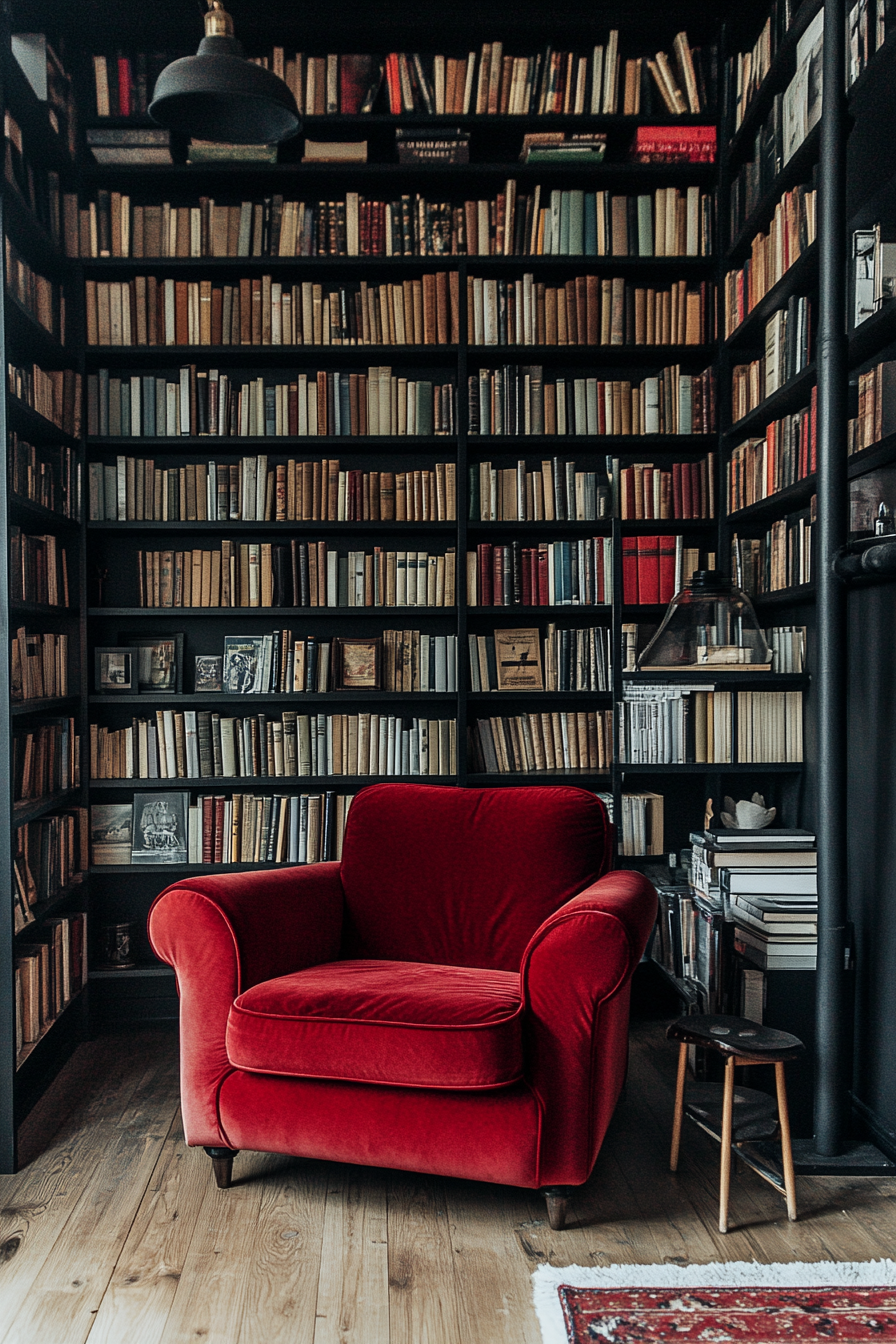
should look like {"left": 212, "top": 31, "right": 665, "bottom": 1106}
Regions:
{"left": 149, "top": 863, "right": 343, "bottom": 1146}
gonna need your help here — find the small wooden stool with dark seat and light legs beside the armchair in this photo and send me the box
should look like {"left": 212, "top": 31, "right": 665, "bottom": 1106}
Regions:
{"left": 666, "top": 1015, "right": 806, "bottom": 1232}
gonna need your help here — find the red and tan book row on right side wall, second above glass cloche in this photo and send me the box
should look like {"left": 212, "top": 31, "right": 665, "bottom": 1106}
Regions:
{"left": 728, "top": 387, "right": 818, "bottom": 513}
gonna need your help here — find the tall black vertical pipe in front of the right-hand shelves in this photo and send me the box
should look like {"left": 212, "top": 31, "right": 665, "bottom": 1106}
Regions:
{"left": 815, "top": 0, "right": 848, "bottom": 1157}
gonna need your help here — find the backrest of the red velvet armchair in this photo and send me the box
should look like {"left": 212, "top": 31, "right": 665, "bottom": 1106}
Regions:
{"left": 341, "top": 784, "right": 613, "bottom": 970}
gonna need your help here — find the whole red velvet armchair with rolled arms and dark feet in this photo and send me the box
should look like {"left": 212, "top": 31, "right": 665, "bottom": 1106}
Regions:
{"left": 149, "top": 784, "right": 656, "bottom": 1227}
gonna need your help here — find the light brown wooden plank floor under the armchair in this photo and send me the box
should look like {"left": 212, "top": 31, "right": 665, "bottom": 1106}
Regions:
{"left": 0, "top": 1021, "right": 896, "bottom": 1344}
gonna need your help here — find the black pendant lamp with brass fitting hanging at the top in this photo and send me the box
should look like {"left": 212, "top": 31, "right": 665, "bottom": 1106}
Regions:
{"left": 149, "top": 0, "right": 302, "bottom": 145}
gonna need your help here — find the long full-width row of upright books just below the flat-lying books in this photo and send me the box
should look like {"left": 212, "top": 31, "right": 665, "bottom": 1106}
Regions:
{"left": 71, "top": 179, "right": 716, "bottom": 259}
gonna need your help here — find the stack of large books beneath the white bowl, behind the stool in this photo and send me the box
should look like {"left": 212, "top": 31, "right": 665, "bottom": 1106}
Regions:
{"left": 690, "top": 828, "right": 818, "bottom": 970}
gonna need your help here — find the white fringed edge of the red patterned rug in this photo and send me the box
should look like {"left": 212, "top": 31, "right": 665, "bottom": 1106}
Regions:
{"left": 532, "top": 1259, "right": 896, "bottom": 1344}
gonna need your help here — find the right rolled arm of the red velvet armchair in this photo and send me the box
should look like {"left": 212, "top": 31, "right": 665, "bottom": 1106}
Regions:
{"left": 520, "top": 872, "right": 657, "bottom": 1185}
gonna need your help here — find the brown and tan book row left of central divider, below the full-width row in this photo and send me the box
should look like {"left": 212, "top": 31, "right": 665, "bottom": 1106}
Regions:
{"left": 85, "top": 270, "right": 459, "bottom": 345}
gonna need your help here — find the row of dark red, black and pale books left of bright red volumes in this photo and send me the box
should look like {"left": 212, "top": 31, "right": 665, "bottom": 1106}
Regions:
{"left": 466, "top": 536, "right": 613, "bottom": 606}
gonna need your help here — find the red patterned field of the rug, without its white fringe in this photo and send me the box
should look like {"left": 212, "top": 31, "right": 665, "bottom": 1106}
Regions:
{"left": 559, "top": 1285, "right": 896, "bottom": 1344}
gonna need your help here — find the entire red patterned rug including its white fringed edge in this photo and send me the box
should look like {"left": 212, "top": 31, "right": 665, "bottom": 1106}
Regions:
{"left": 535, "top": 1261, "right": 896, "bottom": 1344}
